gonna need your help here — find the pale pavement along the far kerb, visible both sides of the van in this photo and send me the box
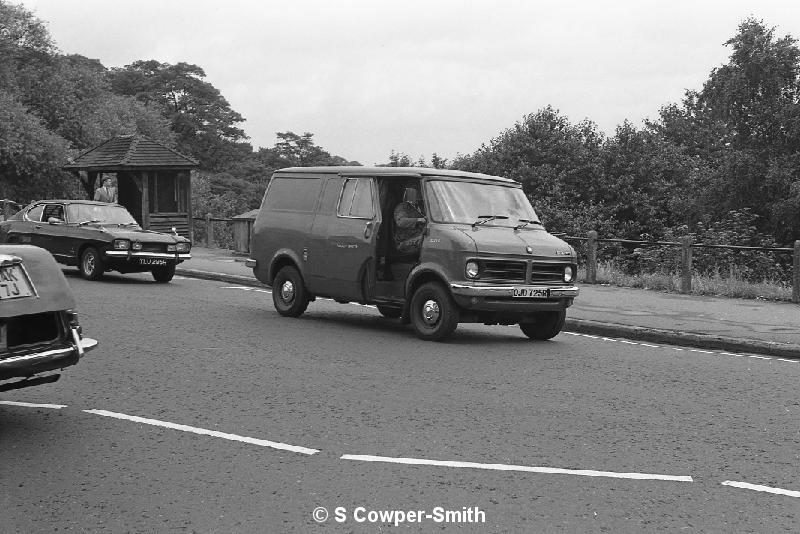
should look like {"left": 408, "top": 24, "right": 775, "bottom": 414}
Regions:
{"left": 176, "top": 247, "right": 800, "bottom": 359}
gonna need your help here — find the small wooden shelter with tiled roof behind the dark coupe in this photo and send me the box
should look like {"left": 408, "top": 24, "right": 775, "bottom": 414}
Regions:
{"left": 63, "top": 135, "right": 199, "bottom": 239}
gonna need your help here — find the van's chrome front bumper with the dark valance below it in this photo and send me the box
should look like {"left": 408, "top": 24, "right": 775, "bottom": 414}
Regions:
{"left": 450, "top": 284, "right": 580, "bottom": 313}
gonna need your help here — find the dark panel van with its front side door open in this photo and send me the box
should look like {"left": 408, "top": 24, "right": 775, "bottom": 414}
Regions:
{"left": 247, "top": 167, "right": 578, "bottom": 340}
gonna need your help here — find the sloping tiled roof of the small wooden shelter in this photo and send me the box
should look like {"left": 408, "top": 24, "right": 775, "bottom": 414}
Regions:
{"left": 63, "top": 135, "right": 199, "bottom": 171}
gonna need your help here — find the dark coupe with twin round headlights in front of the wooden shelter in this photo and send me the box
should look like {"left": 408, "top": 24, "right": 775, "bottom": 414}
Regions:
{"left": 0, "top": 200, "right": 192, "bottom": 282}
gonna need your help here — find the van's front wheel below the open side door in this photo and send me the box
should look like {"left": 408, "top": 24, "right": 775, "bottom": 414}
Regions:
{"left": 409, "top": 282, "right": 460, "bottom": 341}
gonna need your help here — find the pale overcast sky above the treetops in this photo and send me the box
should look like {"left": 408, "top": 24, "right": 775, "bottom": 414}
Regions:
{"left": 10, "top": 0, "right": 800, "bottom": 164}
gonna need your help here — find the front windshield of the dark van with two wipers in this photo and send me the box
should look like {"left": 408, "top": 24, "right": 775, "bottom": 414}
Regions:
{"left": 425, "top": 180, "right": 539, "bottom": 226}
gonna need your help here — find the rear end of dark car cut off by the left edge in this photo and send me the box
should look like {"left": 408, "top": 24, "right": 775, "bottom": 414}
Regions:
{"left": 0, "top": 245, "right": 97, "bottom": 391}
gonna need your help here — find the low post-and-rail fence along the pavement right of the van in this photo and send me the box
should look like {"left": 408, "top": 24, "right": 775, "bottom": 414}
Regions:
{"left": 556, "top": 230, "right": 800, "bottom": 303}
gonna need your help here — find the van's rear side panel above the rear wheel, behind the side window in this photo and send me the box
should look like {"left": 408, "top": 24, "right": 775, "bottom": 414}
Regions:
{"left": 251, "top": 175, "right": 323, "bottom": 284}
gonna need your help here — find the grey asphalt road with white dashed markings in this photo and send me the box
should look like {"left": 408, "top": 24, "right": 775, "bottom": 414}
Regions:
{"left": 0, "top": 271, "right": 800, "bottom": 533}
